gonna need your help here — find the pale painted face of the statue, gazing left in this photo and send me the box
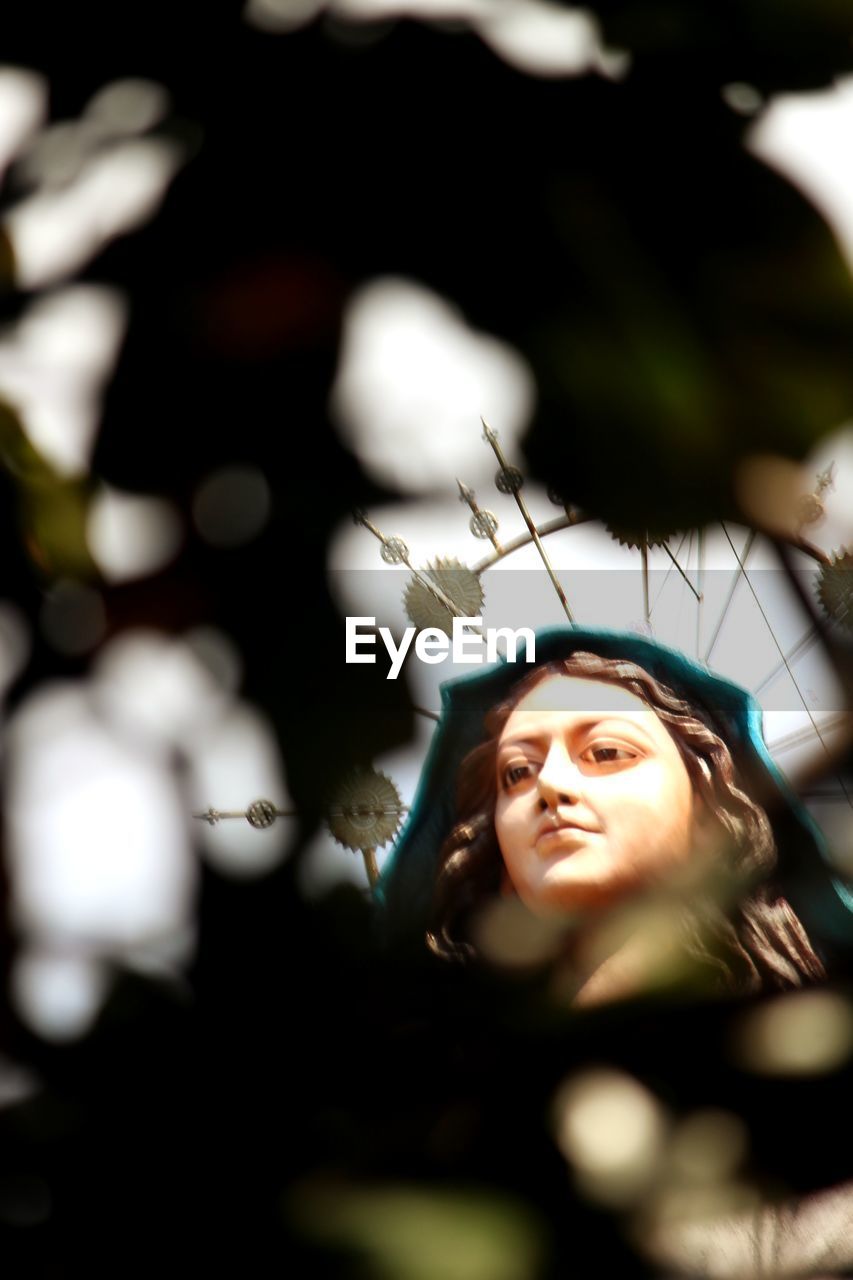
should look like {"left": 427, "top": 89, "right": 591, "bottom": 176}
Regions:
{"left": 494, "top": 676, "right": 694, "bottom": 911}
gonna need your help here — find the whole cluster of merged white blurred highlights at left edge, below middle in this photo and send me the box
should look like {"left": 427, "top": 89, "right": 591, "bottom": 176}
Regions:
{"left": 0, "top": 616, "right": 291, "bottom": 1039}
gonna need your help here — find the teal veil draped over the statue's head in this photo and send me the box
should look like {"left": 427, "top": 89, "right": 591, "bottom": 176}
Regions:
{"left": 377, "top": 627, "right": 853, "bottom": 964}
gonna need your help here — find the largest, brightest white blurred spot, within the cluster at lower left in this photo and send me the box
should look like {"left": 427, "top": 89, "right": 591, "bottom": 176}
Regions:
{"left": 6, "top": 682, "right": 195, "bottom": 948}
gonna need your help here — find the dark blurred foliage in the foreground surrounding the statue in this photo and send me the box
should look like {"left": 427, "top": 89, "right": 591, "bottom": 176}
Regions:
{"left": 0, "top": 0, "right": 853, "bottom": 1280}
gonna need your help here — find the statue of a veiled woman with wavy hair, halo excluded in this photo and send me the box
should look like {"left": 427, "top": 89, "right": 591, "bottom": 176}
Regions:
{"left": 380, "top": 627, "right": 853, "bottom": 1004}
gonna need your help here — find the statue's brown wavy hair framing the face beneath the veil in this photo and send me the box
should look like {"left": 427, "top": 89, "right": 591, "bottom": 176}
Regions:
{"left": 427, "top": 652, "right": 825, "bottom": 993}
